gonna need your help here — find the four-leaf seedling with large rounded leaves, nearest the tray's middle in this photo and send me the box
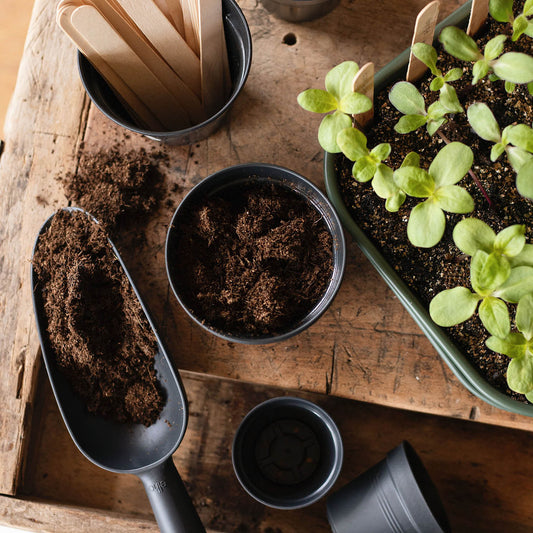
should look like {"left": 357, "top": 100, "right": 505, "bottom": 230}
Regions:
{"left": 393, "top": 142, "right": 474, "bottom": 248}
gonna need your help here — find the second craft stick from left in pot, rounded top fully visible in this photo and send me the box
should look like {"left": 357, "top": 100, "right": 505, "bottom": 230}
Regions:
{"left": 71, "top": 5, "right": 190, "bottom": 130}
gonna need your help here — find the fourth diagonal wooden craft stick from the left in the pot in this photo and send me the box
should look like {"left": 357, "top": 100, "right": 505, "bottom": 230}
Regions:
{"left": 116, "top": 0, "right": 201, "bottom": 96}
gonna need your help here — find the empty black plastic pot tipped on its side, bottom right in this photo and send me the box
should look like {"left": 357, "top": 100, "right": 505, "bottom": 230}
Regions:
{"left": 327, "top": 442, "right": 450, "bottom": 533}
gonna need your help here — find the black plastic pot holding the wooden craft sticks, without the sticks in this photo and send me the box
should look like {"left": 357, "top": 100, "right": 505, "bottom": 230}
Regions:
{"left": 78, "top": 0, "right": 252, "bottom": 145}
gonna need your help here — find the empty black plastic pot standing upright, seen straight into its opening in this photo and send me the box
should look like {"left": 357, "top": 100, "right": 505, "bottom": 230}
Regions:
{"left": 232, "top": 396, "right": 343, "bottom": 509}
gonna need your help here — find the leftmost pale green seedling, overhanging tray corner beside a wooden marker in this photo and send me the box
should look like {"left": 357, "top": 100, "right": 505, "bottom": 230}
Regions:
{"left": 298, "top": 61, "right": 372, "bottom": 153}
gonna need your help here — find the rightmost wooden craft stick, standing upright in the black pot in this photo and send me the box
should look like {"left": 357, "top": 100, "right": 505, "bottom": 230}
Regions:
{"left": 199, "top": 0, "right": 229, "bottom": 116}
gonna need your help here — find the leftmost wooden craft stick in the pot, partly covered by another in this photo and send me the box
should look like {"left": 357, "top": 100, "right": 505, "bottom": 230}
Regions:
{"left": 57, "top": 2, "right": 164, "bottom": 131}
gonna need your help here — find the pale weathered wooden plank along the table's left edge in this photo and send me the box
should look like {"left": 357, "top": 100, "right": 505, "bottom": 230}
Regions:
{"left": 0, "top": 0, "right": 87, "bottom": 494}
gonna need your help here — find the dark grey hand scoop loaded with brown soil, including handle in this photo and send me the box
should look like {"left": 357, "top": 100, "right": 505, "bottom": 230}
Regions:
{"left": 31, "top": 208, "right": 205, "bottom": 533}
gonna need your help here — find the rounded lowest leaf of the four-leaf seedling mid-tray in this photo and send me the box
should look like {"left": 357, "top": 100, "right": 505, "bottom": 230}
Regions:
{"left": 408, "top": 201, "right": 446, "bottom": 248}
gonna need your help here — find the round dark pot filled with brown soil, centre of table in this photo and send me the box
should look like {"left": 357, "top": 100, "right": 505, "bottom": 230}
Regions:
{"left": 166, "top": 163, "right": 346, "bottom": 344}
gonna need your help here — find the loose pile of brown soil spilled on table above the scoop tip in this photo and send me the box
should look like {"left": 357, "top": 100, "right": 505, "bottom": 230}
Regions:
{"left": 60, "top": 144, "right": 168, "bottom": 232}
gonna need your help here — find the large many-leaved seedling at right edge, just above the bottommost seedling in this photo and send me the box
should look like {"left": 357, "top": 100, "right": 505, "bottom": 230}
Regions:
{"left": 429, "top": 218, "right": 533, "bottom": 338}
